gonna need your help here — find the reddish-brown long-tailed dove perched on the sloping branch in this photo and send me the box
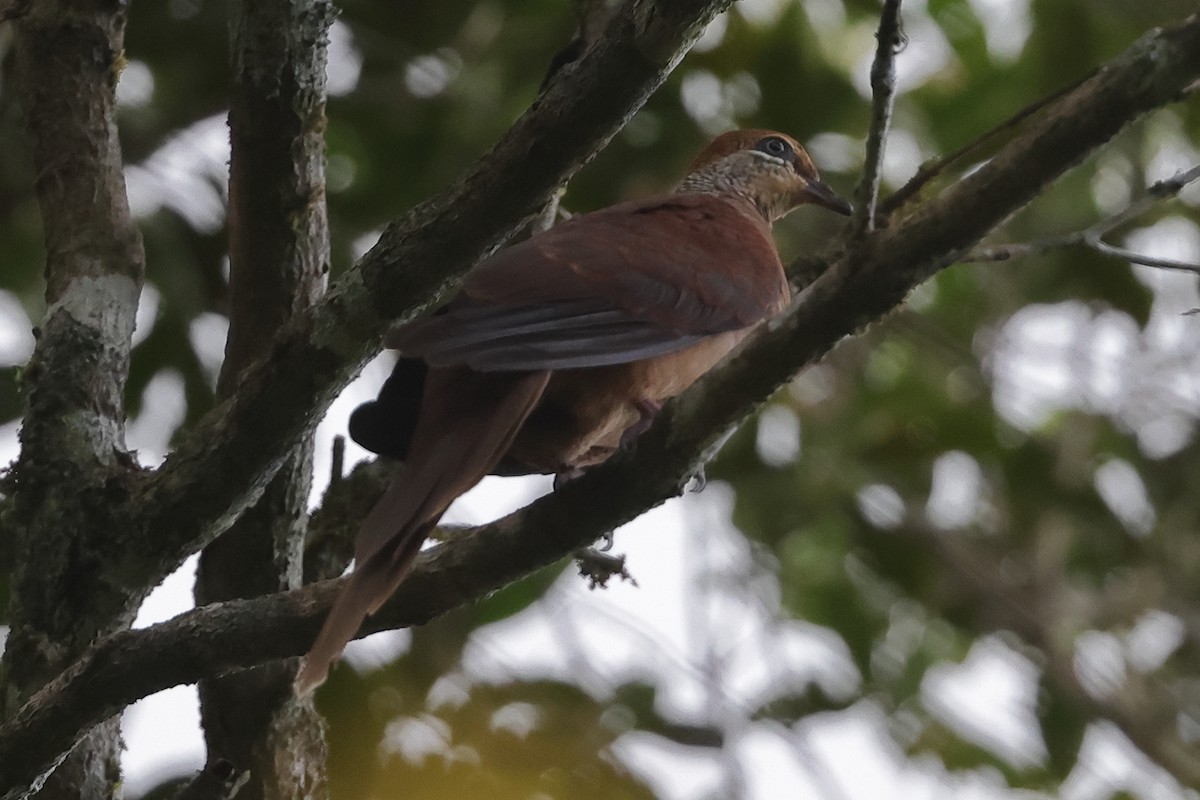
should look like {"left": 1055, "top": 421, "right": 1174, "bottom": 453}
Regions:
{"left": 295, "top": 130, "right": 851, "bottom": 693}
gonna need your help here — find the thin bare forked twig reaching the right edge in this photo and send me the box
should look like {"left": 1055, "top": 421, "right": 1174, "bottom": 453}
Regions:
{"left": 961, "top": 164, "right": 1200, "bottom": 272}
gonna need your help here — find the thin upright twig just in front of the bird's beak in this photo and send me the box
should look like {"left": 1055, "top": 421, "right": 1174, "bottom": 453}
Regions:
{"left": 850, "top": 0, "right": 906, "bottom": 237}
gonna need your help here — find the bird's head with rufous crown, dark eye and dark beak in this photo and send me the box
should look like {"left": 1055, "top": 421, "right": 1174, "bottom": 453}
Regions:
{"left": 679, "top": 130, "right": 851, "bottom": 222}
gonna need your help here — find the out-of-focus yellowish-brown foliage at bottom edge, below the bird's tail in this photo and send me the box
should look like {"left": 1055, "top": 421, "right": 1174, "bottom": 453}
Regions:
{"left": 320, "top": 612, "right": 653, "bottom": 799}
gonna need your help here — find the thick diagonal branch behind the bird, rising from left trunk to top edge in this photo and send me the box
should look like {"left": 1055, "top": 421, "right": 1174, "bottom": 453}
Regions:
{"left": 121, "top": 0, "right": 731, "bottom": 618}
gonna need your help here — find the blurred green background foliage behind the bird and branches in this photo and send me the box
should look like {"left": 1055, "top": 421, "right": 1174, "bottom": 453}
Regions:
{"left": 0, "top": 0, "right": 1200, "bottom": 798}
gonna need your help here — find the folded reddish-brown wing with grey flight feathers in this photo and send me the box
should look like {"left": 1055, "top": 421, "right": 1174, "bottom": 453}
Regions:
{"left": 389, "top": 196, "right": 787, "bottom": 372}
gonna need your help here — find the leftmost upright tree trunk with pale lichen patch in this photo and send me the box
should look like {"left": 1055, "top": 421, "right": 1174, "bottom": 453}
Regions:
{"left": 0, "top": 0, "right": 145, "bottom": 800}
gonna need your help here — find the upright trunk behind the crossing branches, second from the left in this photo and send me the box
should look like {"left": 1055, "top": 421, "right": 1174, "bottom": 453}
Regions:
{"left": 196, "top": 0, "right": 334, "bottom": 800}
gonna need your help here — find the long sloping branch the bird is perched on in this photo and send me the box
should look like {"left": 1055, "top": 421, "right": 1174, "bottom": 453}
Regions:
{"left": 0, "top": 16, "right": 1200, "bottom": 790}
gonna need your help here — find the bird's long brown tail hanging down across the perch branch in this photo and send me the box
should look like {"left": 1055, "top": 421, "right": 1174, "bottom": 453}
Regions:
{"left": 295, "top": 367, "right": 550, "bottom": 693}
